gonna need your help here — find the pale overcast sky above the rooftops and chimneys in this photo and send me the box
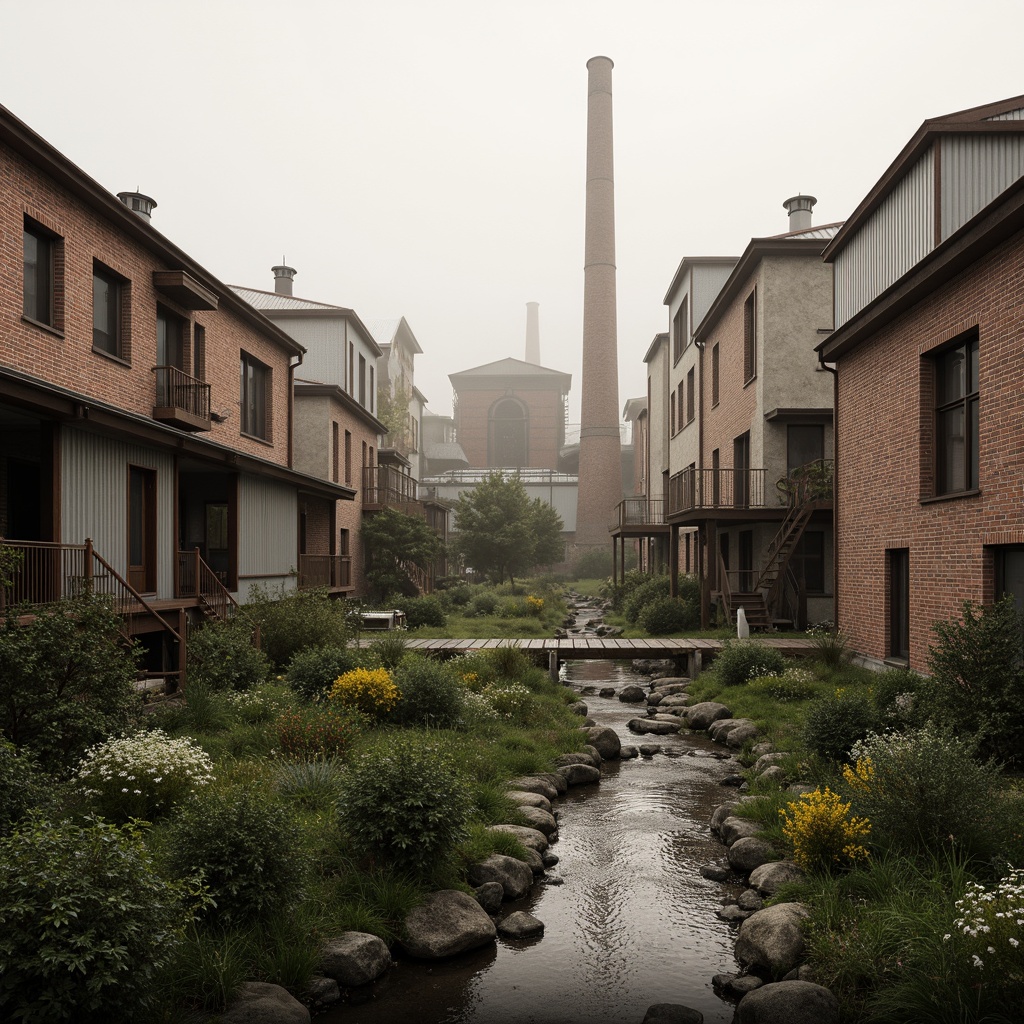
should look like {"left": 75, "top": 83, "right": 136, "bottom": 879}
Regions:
{"left": 0, "top": 0, "right": 1024, "bottom": 420}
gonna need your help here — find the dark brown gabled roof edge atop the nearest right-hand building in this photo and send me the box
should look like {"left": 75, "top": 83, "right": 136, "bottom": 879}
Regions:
{"left": 821, "top": 95, "right": 1024, "bottom": 262}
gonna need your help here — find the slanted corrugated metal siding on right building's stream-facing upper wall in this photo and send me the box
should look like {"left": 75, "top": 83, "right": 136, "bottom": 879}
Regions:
{"left": 835, "top": 150, "right": 935, "bottom": 328}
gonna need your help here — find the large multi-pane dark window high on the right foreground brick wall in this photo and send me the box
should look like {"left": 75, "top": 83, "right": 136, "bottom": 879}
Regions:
{"left": 935, "top": 334, "right": 978, "bottom": 495}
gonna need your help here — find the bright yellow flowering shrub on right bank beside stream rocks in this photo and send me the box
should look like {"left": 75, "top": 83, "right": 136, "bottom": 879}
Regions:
{"left": 778, "top": 786, "right": 871, "bottom": 871}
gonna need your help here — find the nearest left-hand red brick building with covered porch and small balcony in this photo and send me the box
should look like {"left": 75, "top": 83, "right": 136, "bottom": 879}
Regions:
{"left": 0, "top": 108, "right": 352, "bottom": 684}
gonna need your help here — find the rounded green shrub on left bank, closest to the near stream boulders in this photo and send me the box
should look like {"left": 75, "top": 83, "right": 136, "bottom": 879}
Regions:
{"left": 338, "top": 733, "right": 472, "bottom": 877}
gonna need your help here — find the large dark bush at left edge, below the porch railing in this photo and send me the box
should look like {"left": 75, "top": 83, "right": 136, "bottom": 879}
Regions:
{"left": 0, "top": 597, "right": 137, "bottom": 770}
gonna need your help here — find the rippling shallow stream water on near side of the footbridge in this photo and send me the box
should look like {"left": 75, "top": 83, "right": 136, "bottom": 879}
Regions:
{"left": 327, "top": 662, "right": 736, "bottom": 1024}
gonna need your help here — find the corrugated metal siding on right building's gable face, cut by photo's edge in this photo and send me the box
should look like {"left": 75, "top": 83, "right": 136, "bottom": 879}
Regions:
{"left": 941, "top": 134, "right": 1024, "bottom": 241}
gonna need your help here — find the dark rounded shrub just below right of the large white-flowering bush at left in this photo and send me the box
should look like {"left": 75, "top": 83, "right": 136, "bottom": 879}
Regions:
{"left": 168, "top": 787, "right": 305, "bottom": 927}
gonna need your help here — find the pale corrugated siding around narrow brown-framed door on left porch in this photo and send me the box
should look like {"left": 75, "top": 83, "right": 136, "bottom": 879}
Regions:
{"left": 60, "top": 428, "right": 176, "bottom": 598}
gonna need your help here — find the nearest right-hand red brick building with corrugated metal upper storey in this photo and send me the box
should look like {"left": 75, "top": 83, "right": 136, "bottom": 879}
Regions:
{"left": 821, "top": 96, "right": 1024, "bottom": 670}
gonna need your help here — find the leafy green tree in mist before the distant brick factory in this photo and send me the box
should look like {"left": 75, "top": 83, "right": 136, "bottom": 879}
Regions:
{"left": 455, "top": 472, "right": 562, "bottom": 583}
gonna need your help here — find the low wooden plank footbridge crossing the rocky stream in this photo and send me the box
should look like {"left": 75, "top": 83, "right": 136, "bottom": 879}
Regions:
{"left": 360, "top": 634, "right": 815, "bottom": 678}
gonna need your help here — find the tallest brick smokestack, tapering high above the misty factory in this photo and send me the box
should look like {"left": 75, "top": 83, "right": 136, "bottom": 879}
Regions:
{"left": 575, "top": 57, "right": 623, "bottom": 548}
